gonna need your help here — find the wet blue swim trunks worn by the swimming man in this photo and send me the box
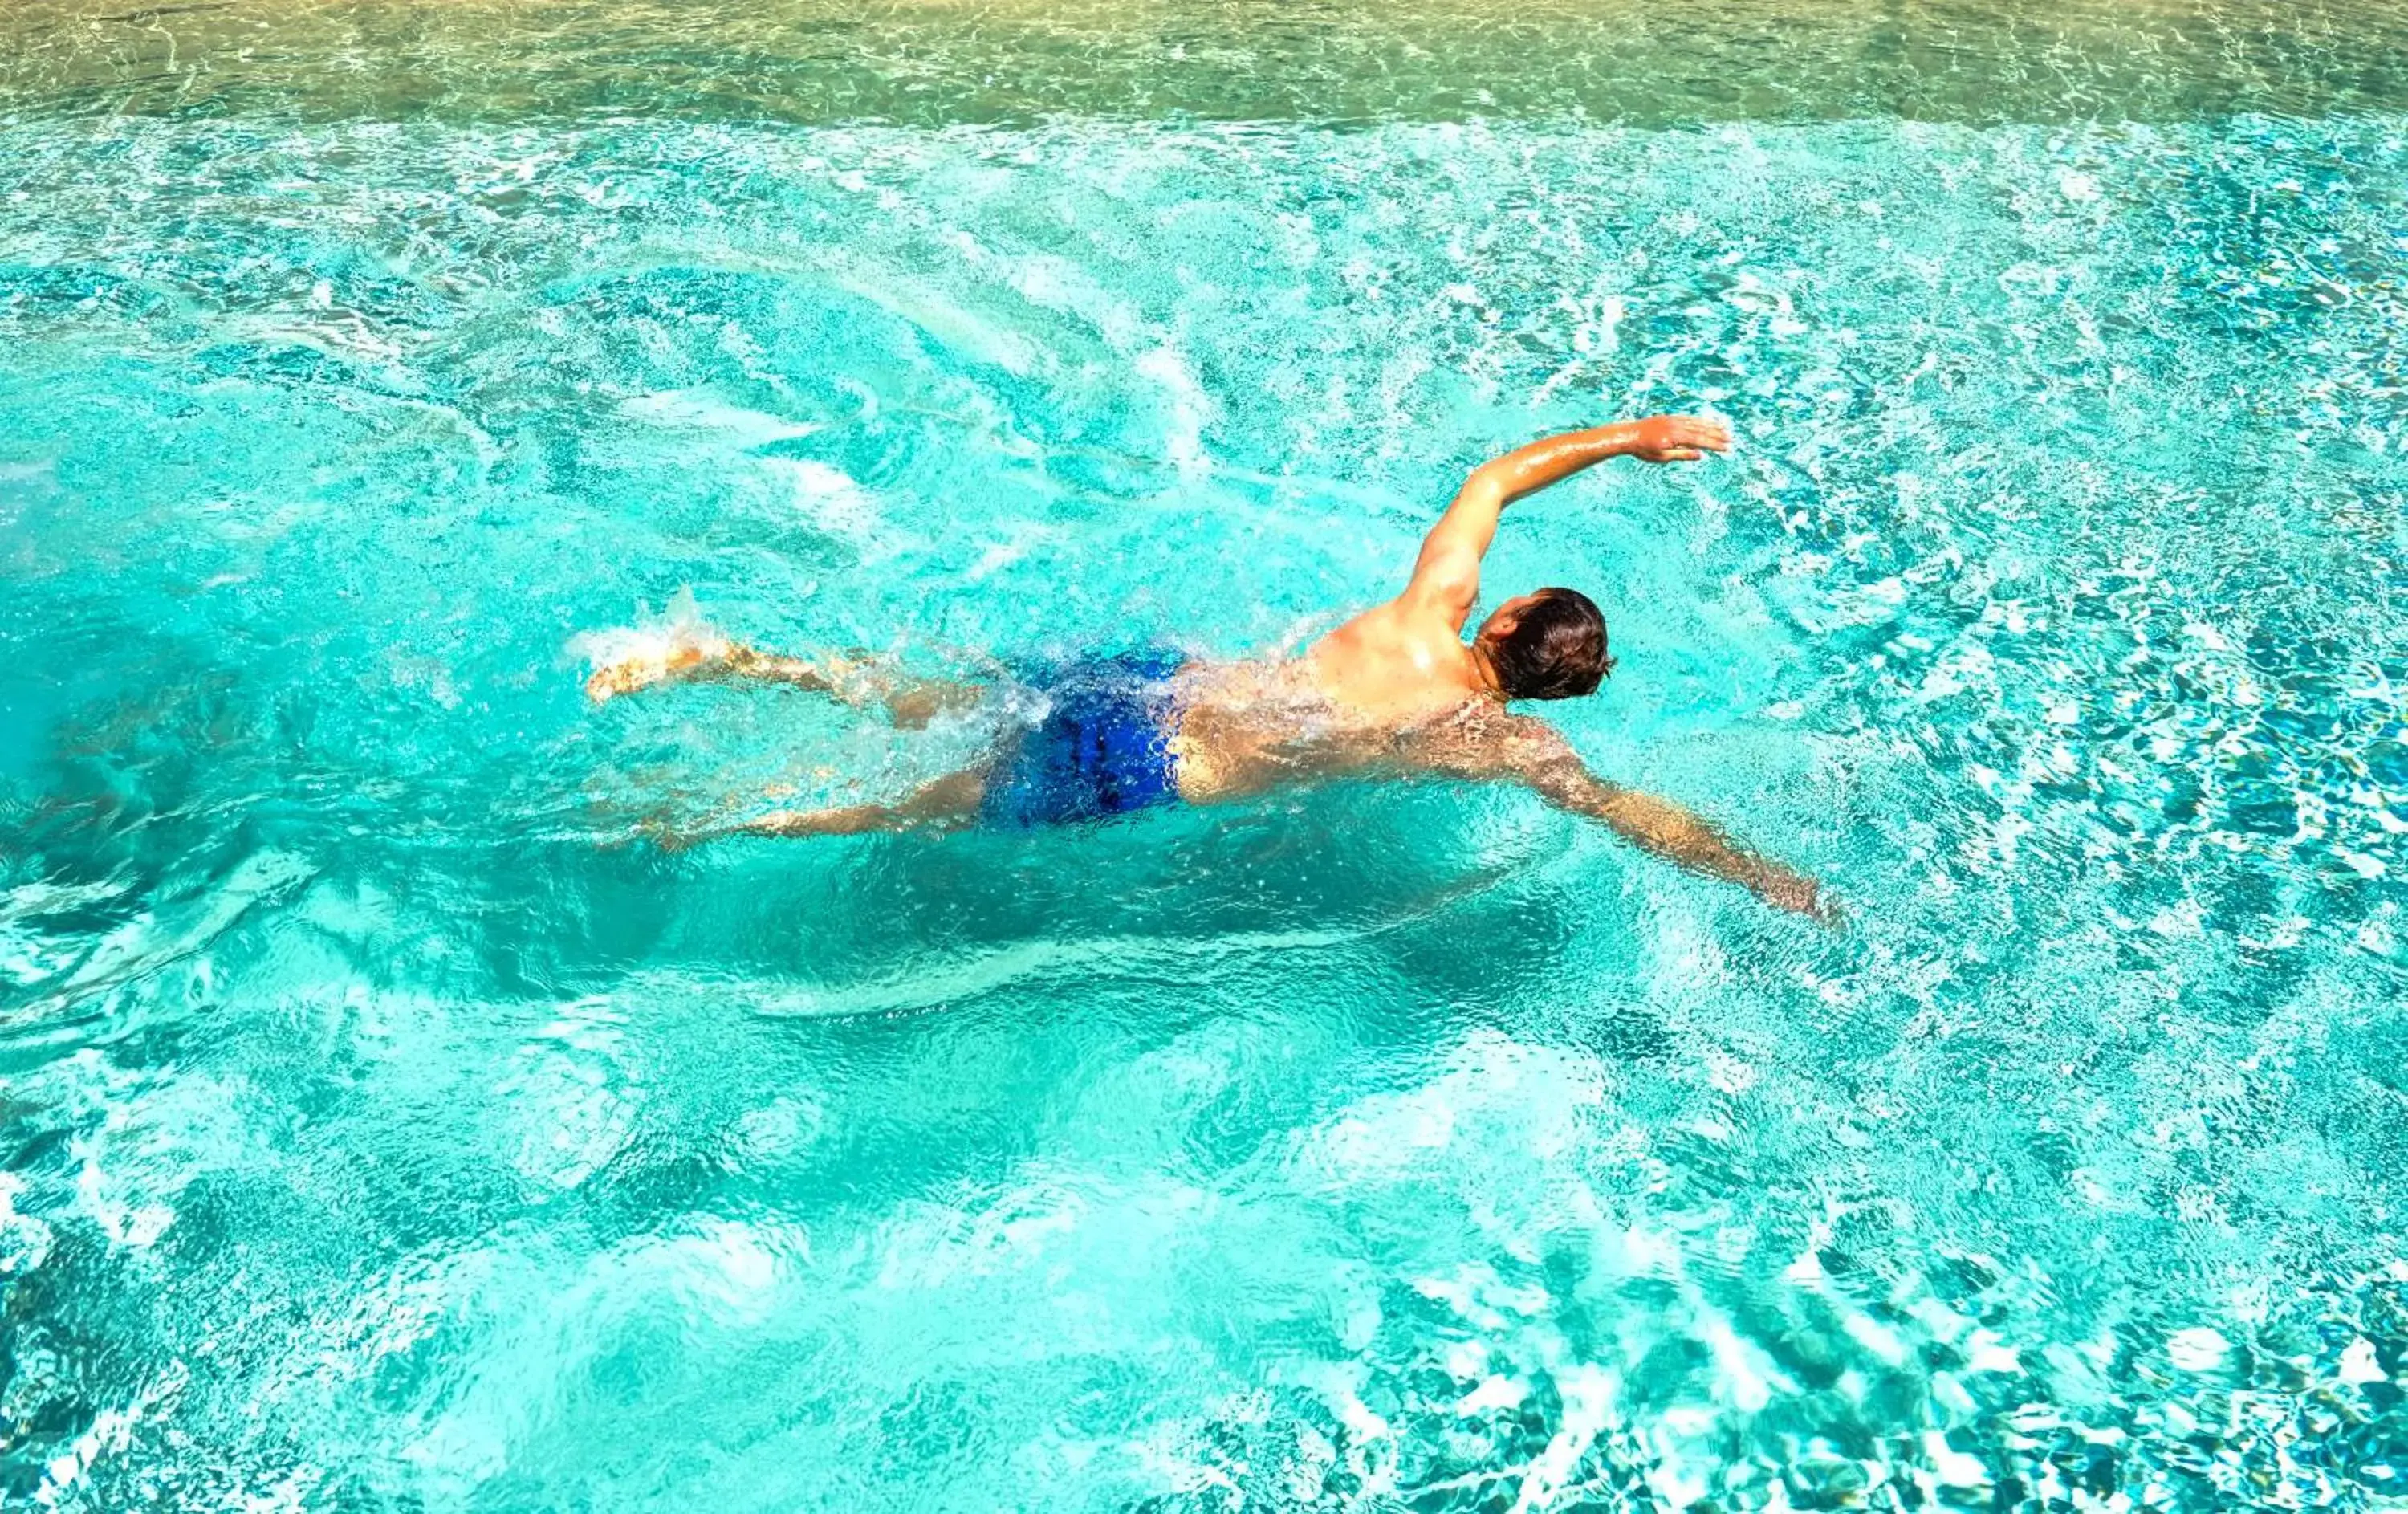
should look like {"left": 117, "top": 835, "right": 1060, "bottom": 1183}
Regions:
{"left": 980, "top": 650, "right": 1185, "bottom": 825}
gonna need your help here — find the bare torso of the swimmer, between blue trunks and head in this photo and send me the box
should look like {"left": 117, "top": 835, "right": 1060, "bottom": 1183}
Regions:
{"left": 1170, "top": 604, "right": 1503, "bottom": 804}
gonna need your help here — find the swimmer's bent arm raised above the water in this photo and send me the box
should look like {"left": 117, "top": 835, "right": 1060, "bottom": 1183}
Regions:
{"left": 1401, "top": 417, "right": 1731, "bottom": 631}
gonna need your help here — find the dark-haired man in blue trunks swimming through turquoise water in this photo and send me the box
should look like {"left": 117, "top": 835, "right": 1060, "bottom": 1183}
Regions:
{"left": 585, "top": 406, "right": 1837, "bottom": 924}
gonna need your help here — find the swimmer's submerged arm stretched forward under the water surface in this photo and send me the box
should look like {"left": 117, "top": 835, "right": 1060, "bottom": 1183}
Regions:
{"left": 1445, "top": 718, "right": 1840, "bottom": 926}
